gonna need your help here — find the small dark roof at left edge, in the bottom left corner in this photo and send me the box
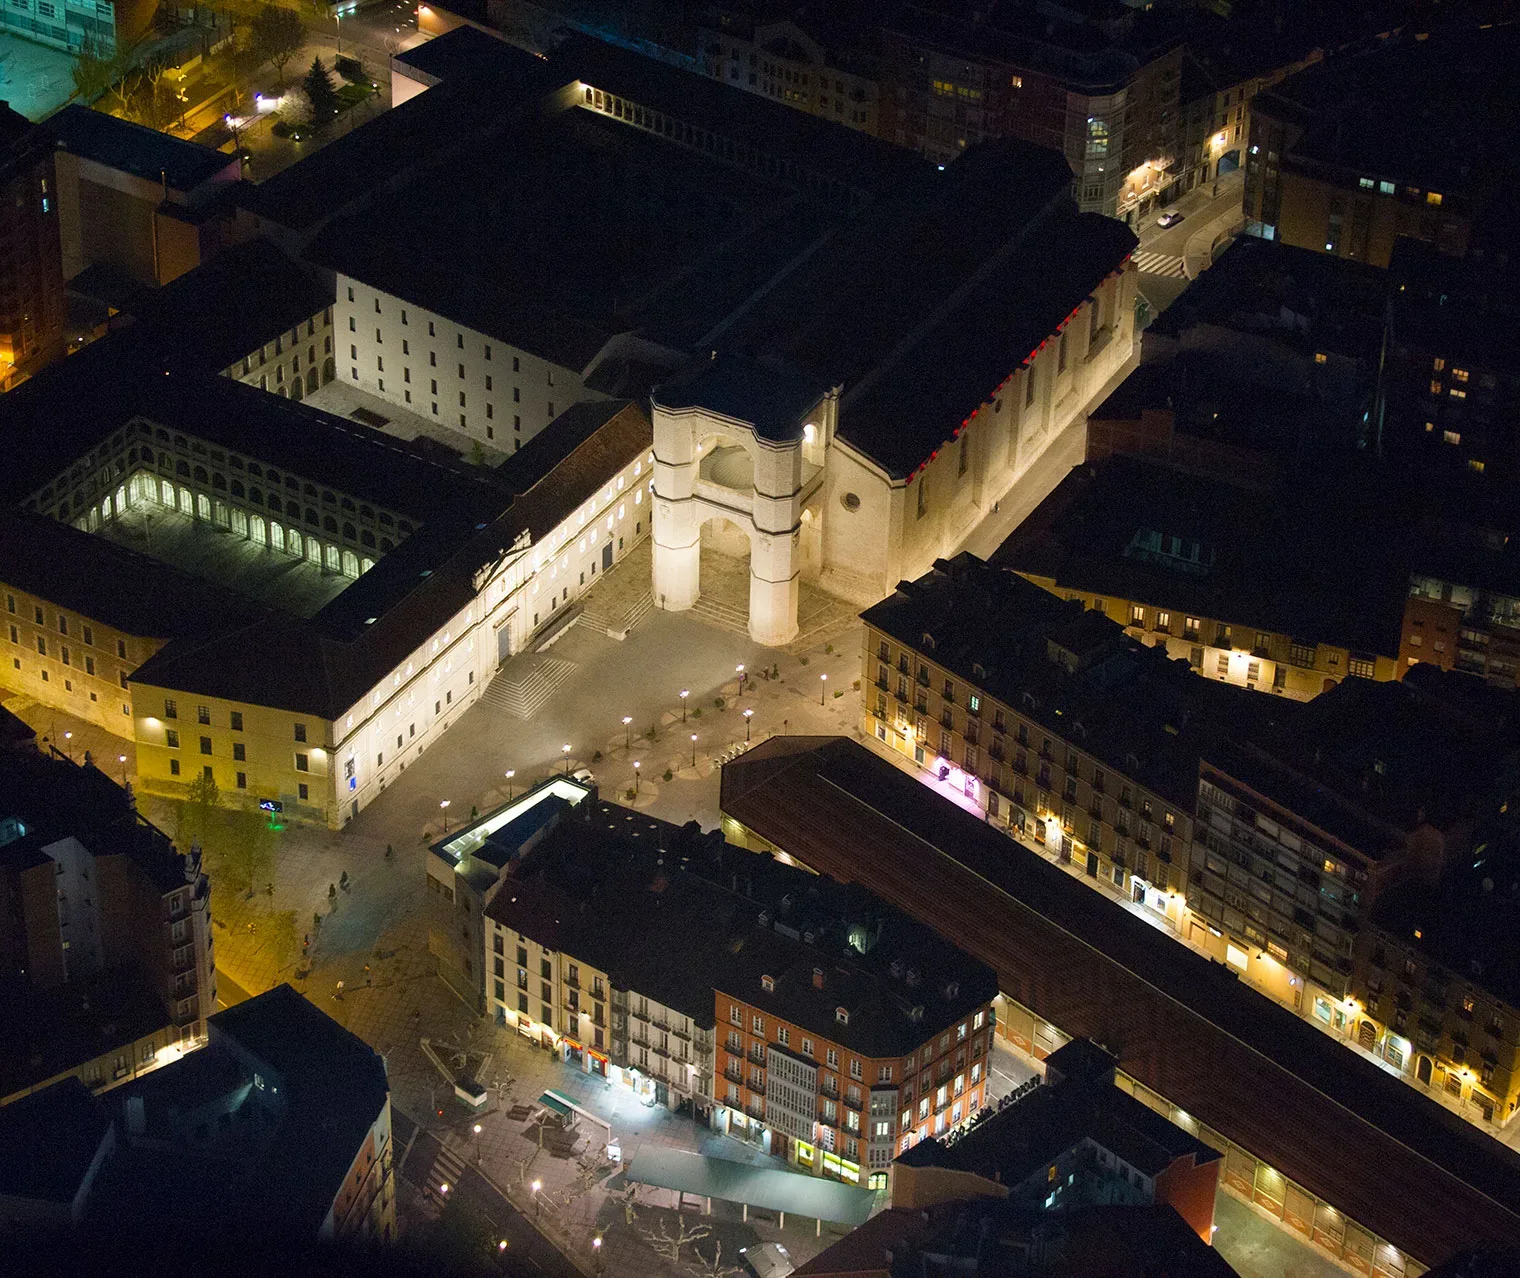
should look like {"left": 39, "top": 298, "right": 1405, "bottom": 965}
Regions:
{"left": 0, "top": 1077, "right": 111, "bottom": 1207}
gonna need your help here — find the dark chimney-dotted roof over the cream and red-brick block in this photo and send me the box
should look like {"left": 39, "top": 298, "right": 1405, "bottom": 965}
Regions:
{"left": 486, "top": 802, "right": 996, "bottom": 1056}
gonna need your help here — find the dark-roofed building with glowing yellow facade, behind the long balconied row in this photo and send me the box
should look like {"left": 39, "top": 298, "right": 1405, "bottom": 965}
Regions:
{"left": 991, "top": 456, "right": 1410, "bottom": 701}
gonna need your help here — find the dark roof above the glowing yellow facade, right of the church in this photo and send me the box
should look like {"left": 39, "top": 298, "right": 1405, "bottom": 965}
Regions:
{"left": 991, "top": 456, "right": 1412, "bottom": 656}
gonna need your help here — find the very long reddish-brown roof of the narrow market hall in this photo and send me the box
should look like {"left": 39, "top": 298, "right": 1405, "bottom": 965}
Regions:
{"left": 720, "top": 737, "right": 1520, "bottom": 1261}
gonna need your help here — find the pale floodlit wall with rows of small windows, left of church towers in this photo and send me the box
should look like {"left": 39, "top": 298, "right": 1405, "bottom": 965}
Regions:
{"left": 333, "top": 275, "right": 602, "bottom": 453}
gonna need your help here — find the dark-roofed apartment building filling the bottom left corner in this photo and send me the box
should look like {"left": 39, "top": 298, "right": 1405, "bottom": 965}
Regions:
{"left": 0, "top": 985, "right": 395, "bottom": 1258}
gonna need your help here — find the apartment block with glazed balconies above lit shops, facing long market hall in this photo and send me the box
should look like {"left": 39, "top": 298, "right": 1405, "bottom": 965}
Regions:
{"left": 1187, "top": 667, "right": 1514, "bottom": 1021}
